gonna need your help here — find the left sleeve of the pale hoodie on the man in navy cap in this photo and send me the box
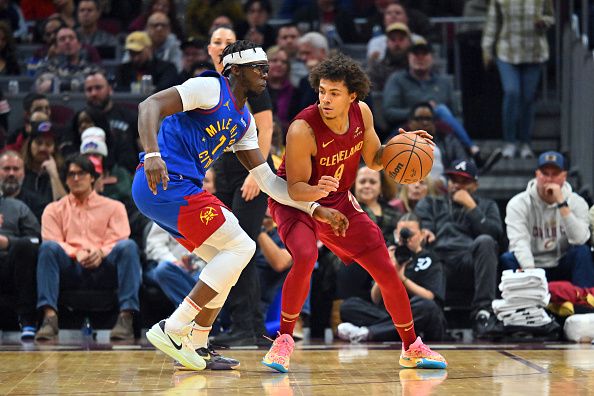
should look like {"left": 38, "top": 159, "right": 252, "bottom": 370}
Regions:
{"left": 505, "top": 195, "right": 534, "bottom": 269}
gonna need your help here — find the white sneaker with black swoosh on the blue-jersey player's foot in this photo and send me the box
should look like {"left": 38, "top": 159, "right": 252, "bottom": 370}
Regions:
{"left": 146, "top": 320, "right": 206, "bottom": 371}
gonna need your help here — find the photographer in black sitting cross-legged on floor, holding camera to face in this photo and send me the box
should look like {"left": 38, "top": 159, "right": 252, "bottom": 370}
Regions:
{"left": 338, "top": 213, "right": 446, "bottom": 342}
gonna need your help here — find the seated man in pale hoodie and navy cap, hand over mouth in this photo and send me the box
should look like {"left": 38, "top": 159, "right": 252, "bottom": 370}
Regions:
{"left": 501, "top": 151, "right": 594, "bottom": 287}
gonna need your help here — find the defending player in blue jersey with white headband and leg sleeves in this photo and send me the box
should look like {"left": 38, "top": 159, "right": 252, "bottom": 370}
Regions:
{"left": 132, "top": 41, "right": 348, "bottom": 370}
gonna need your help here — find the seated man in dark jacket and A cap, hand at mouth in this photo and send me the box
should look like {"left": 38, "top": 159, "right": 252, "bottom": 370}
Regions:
{"left": 415, "top": 159, "right": 503, "bottom": 338}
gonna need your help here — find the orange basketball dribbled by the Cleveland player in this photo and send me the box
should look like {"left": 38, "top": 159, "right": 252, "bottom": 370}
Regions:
{"left": 382, "top": 133, "right": 433, "bottom": 184}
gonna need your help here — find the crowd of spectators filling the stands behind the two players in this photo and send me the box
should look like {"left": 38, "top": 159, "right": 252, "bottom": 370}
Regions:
{"left": 0, "top": 0, "right": 594, "bottom": 345}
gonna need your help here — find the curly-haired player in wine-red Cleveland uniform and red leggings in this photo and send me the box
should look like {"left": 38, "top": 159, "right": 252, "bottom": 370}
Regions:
{"left": 262, "top": 54, "right": 447, "bottom": 372}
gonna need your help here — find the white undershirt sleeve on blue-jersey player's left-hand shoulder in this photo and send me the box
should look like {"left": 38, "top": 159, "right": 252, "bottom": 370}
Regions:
{"left": 175, "top": 77, "right": 221, "bottom": 111}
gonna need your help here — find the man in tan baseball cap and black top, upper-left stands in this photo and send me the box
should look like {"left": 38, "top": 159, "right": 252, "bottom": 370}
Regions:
{"left": 116, "top": 31, "right": 177, "bottom": 91}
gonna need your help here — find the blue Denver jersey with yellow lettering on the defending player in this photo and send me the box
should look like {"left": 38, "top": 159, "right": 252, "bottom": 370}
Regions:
{"left": 141, "top": 72, "right": 251, "bottom": 186}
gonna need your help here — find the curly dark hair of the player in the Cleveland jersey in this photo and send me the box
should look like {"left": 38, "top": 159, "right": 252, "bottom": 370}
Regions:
{"left": 309, "top": 53, "right": 371, "bottom": 100}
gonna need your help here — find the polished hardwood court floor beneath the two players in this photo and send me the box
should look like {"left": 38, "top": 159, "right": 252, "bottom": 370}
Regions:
{"left": 0, "top": 343, "right": 594, "bottom": 396}
